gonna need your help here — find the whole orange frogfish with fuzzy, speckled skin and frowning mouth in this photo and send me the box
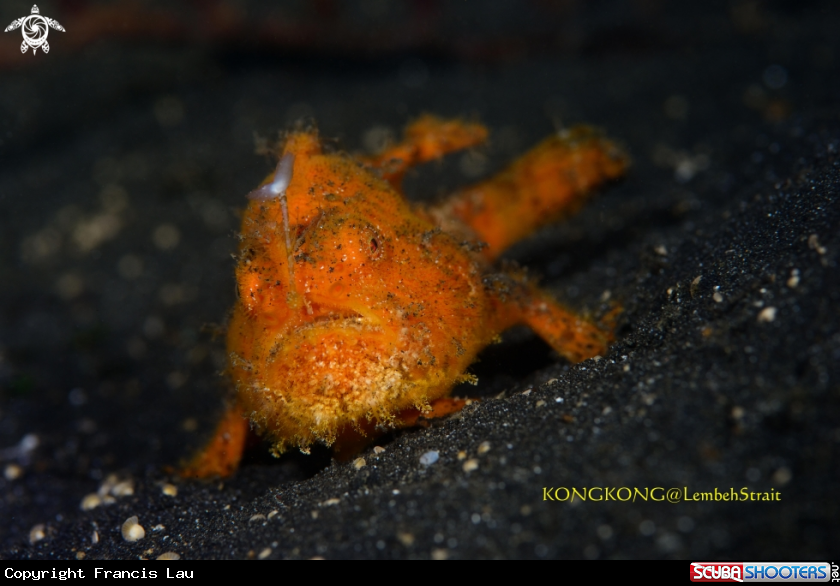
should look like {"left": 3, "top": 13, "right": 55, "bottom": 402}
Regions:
{"left": 183, "top": 116, "right": 628, "bottom": 476}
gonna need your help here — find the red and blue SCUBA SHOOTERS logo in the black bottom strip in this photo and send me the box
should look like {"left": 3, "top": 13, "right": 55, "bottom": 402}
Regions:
{"left": 690, "top": 562, "right": 838, "bottom": 583}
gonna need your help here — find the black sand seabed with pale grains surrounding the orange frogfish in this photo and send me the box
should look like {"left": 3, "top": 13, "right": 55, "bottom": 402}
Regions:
{"left": 0, "top": 2, "right": 840, "bottom": 559}
